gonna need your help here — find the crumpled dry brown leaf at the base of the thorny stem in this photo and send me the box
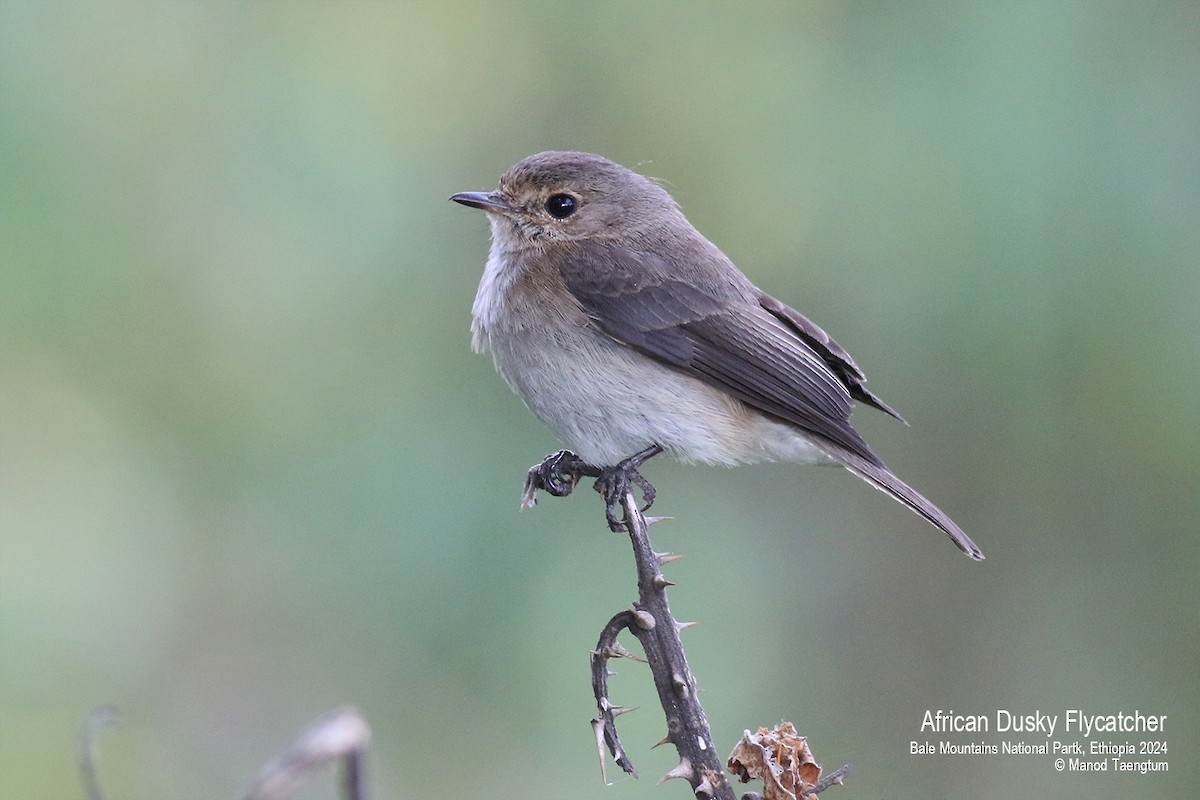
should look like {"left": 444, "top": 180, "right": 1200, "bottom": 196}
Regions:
{"left": 728, "top": 722, "right": 821, "bottom": 800}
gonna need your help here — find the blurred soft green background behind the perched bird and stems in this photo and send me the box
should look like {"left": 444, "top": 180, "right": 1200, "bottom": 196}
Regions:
{"left": 0, "top": 0, "right": 1200, "bottom": 800}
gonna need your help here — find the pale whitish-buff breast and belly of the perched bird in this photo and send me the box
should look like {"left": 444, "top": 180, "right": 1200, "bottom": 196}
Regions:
{"left": 472, "top": 244, "right": 828, "bottom": 465}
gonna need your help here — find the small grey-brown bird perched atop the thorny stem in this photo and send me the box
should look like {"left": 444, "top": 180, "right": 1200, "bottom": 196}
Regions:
{"left": 450, "top": 152, "right": 983, "bottom": 559}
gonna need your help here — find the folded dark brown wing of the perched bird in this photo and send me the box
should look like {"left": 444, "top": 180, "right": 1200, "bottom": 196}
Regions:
{"left": 556, "top": 243, "right": 894, "bottom": 465}
